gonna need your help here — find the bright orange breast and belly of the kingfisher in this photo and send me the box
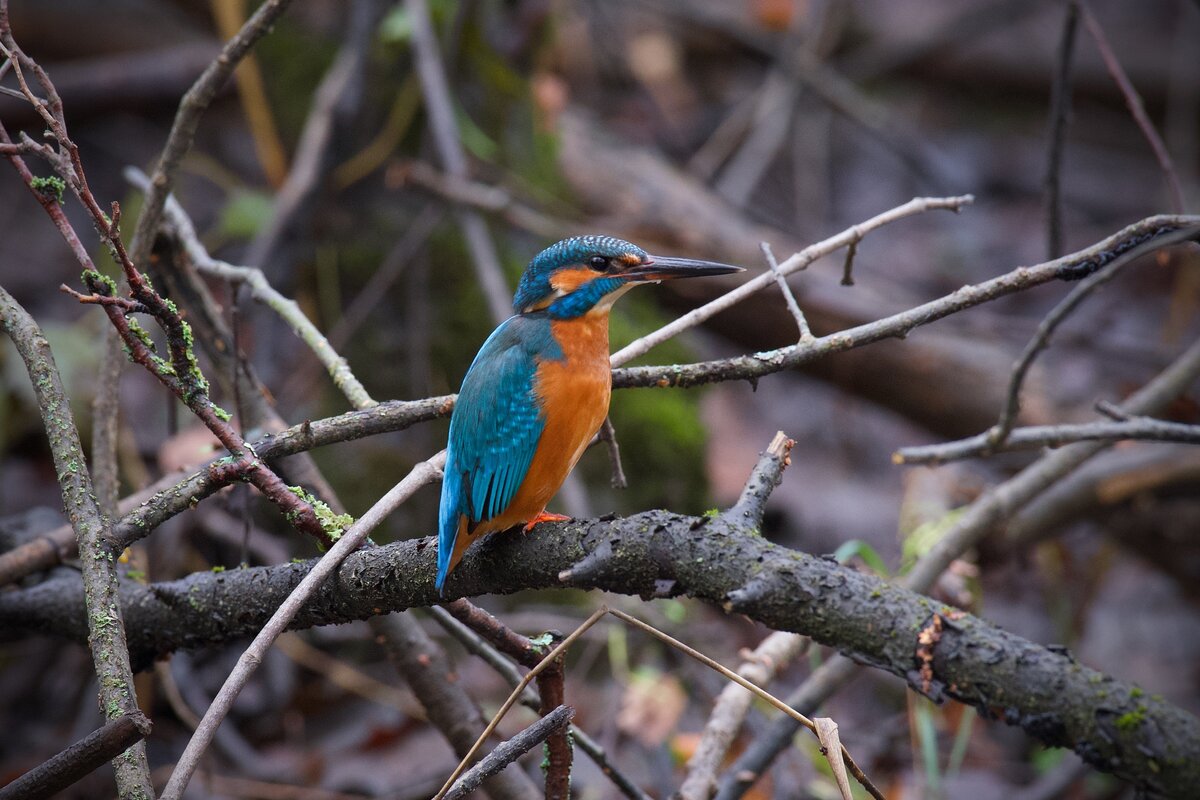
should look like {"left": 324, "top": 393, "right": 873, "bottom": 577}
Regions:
{"left": 474, "top": 309, "right": 612, "bottom": 534}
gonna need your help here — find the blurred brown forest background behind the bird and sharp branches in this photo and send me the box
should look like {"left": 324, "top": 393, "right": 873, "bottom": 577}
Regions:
{"left": 0, "top": 0, "right": 1200, "bottom": 800}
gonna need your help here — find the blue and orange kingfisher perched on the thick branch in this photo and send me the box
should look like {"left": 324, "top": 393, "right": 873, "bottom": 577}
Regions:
{"left": 436, "top": 236, "right": 742, "bottom": 594}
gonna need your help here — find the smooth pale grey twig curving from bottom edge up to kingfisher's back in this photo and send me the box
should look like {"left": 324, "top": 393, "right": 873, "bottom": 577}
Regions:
{"left": 162, "top": 451, "right": 445, "bottom": 800}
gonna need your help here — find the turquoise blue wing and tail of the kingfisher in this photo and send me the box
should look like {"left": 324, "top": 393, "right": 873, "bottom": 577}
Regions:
{"left": 437, "top": 318, "right": 553, "bottom": 591}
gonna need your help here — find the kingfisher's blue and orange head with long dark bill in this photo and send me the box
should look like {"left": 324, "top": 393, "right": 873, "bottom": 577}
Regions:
{"left": 512, "top": 236, "right": 742, "bottom": 319}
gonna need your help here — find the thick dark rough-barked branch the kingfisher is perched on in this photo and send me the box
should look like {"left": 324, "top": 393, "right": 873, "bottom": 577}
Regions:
{"left": 0, "top": 511, "right": 1200, "bottom": 795}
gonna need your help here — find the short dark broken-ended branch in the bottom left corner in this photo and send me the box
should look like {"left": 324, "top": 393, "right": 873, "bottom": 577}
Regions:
{"left": 0, "top": 709, "right": 151, "bottom": 800}
